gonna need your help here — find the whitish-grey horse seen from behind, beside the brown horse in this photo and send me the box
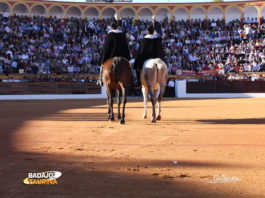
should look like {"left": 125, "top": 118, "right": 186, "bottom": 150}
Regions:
{"left": 141, "top": 58, "right": 168, "bottom": 122}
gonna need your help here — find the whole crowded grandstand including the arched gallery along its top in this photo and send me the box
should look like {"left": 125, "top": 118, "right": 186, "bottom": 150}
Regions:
{"left": 0, "top": 1, "right": 265, "bottom": 80}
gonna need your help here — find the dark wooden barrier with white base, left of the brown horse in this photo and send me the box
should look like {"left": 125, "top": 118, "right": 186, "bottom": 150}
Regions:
{"left": 0, "top": 82, "right": 107, "bottom": 100}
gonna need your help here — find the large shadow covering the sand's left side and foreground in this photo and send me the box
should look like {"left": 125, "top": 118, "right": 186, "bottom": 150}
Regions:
{"left": 0, "top": 100, "right": 255, "bottom": 198}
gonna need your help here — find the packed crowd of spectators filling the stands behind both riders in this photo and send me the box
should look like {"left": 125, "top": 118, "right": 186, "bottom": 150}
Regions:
{"left": 0, "top": 15, "right": 265, "bottom": 77}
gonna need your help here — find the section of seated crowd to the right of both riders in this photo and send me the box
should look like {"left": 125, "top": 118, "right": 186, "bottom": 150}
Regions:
{"left": 165, "top": 16, "right": 265, "bottom": 74}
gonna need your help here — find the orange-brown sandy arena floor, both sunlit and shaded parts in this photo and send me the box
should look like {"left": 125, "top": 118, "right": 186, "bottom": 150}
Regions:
{"left": 0, "top": 99, "right": 265, "bottom": 198}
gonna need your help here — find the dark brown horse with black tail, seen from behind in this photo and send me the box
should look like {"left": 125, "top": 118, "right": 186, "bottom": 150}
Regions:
{"left": 102, "top": 57, "right": 132, "bottom": 124}
